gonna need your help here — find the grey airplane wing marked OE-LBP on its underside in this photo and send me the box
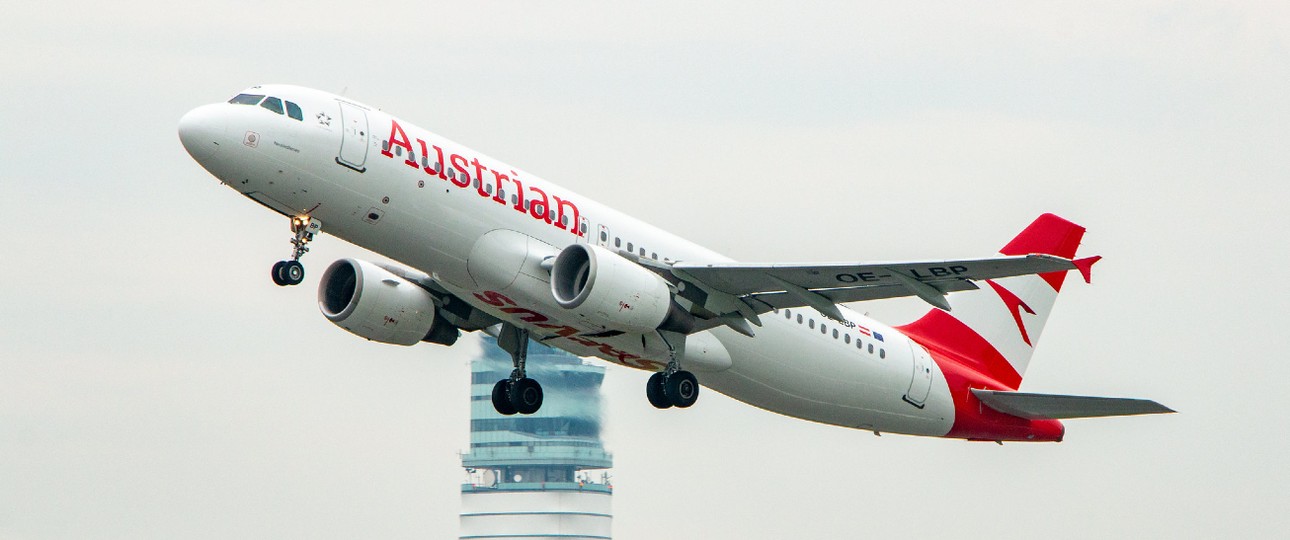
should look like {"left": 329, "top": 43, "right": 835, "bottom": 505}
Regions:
{"left": 660, "top": 253, "right": 1077, "bottom": 335}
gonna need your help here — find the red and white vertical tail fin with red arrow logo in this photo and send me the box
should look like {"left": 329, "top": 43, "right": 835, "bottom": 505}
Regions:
{"left": 899, "top": 214, "right": 1097, "bottom": 389}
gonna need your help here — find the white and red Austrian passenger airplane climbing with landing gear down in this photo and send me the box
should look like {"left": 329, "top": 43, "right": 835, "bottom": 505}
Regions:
{"left": 178, "top": 85, "right": 1174, "bottom": 443}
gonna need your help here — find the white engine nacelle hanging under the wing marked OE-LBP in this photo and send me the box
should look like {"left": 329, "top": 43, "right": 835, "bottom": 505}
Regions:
{"left": 551, "top": 244, "right": 672, "bottom": 334}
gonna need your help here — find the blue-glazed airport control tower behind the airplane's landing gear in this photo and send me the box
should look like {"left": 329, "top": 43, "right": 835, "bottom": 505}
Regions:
{"left": 461, "top": 338, "right": 613, "bottom": 539}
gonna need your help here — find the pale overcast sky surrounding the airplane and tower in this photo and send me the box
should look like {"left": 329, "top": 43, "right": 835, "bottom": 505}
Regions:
{"left": 0, "top": 0, "right": 1290, "bottom": 540}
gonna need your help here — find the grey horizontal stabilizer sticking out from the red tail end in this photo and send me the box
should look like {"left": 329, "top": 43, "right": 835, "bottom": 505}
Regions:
{"left": 971, "top": 388, "right": 1174, "bottom": 420}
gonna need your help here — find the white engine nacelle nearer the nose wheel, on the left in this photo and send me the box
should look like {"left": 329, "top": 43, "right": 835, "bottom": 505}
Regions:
{"left": 319, "top": 259, "right": 458, "bottom": 345}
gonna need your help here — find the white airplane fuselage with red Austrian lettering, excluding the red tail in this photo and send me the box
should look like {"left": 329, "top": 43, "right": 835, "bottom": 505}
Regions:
{"left": 186, "top": 85, "right": 955, "bottom": 436}
